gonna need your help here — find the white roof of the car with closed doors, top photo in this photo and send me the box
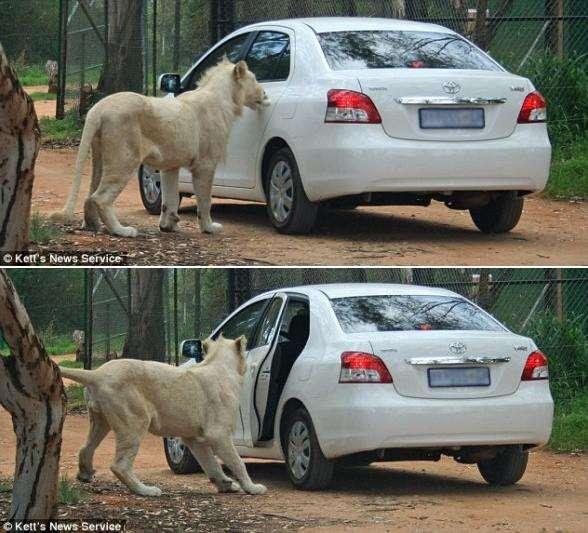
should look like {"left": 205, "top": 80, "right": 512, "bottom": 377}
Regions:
{"left": 240, "top": 17, "right": 453, "bottom": 33}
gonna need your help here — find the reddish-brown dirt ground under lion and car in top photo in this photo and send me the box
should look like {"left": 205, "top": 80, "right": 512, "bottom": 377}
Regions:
{"left": 32, "top": 149, "right": 588, "bottom": 266}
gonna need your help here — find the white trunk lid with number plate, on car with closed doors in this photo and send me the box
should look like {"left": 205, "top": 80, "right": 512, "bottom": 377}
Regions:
{"left": 349, "top": 68, "right": 532, "bottom": 141}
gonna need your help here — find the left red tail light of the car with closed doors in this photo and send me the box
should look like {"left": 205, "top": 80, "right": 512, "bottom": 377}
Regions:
{"left": 325, "top": 89, "right": 382, "bottom": 124}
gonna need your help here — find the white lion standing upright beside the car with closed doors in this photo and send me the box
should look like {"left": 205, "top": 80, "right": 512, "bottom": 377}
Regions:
{"left": 53, "top": 58, "right": 269, "bottom": 237}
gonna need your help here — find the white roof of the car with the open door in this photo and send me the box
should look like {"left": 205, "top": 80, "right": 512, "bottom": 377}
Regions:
{"left": 259, "top": 283, "right": 459, "bottom": 298}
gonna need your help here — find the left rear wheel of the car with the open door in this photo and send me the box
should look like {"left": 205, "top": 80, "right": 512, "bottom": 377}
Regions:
{"left": 283, "top": 408, "right": 334, "bottom": 490}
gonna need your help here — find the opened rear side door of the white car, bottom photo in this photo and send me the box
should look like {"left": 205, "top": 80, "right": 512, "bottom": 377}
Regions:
{"left": 238, "top": 293, "right": 286, "bottom": 446}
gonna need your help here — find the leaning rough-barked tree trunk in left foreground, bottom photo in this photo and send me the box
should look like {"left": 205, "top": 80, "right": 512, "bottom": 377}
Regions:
{"left": 0, "top": 270, "right": 65, "bottom": 519}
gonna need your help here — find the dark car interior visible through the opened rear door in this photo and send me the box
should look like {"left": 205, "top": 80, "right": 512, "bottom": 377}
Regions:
{"left": 259, "top": 298, "right": 310, "bottom": 441}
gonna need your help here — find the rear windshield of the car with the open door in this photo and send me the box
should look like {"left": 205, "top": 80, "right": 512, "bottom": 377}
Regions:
{"left": 331, "top": 295, "right": 503, "bottom": 333}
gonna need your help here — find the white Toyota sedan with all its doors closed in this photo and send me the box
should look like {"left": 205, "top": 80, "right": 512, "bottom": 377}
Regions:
{"left": 139, "top": 17, "right": 551, "bottom": 233}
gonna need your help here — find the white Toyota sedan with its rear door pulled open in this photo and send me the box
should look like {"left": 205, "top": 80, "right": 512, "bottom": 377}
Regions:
{"left": 164, "top": 284, "right": 553, "bottom": 489}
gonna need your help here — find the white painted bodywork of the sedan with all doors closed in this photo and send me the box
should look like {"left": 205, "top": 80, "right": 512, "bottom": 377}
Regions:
{"left": 168, "top": 17, "right": 551, "bottom": 206}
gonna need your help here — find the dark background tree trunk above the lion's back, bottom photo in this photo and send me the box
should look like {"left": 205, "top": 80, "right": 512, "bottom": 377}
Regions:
{"left": 123, "top": 268, "right": 166, "bottom": 361}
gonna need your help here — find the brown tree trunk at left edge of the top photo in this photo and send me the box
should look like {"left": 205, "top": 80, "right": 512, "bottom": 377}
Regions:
{"left": 0, "top": 44, "right": 40, "bottom": 250}
